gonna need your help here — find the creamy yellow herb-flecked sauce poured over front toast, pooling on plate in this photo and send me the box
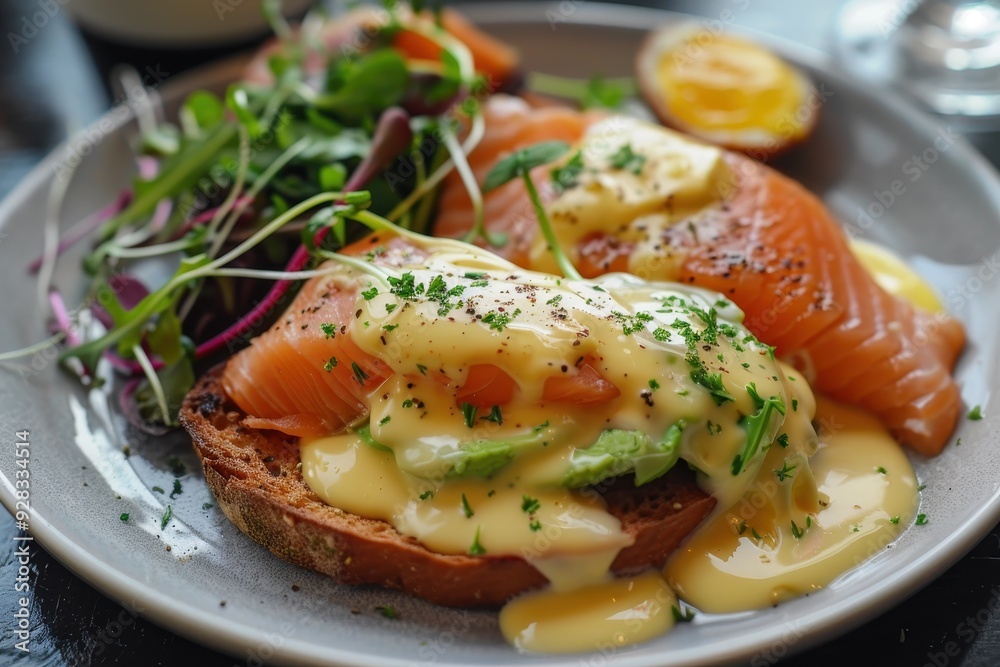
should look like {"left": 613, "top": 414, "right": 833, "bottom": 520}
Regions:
{"left": 290, "top": 240, "right": 916, "bottom": 652}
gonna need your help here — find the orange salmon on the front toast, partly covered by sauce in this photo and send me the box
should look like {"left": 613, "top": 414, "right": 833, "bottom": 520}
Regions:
{"left": 221, "top": 234, "right": 621, "bottom": 437}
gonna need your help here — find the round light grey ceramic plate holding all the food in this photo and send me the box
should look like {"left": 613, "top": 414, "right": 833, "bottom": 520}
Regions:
{"left": 0, "top": 3, "right": 1000, "bottom": 667}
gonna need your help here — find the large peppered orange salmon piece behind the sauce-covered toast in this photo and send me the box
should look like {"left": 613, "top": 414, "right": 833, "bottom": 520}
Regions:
{"left": 434, "top": 96, "right": 965, "bottom": 455}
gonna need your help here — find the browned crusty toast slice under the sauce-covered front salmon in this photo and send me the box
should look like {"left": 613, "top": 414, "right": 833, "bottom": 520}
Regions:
{"left": 180, "top": 366, "right": 715, "bottom": 607}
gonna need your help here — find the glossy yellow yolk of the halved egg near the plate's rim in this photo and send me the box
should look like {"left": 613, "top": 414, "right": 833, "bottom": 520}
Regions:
{"left": 658, "top": 35, "right": 804, "bottom": 134}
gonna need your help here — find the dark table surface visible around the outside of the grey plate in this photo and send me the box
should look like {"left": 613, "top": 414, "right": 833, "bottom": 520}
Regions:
{"left": 0, "top": 0, "right": 1000, "bottom": 667}
